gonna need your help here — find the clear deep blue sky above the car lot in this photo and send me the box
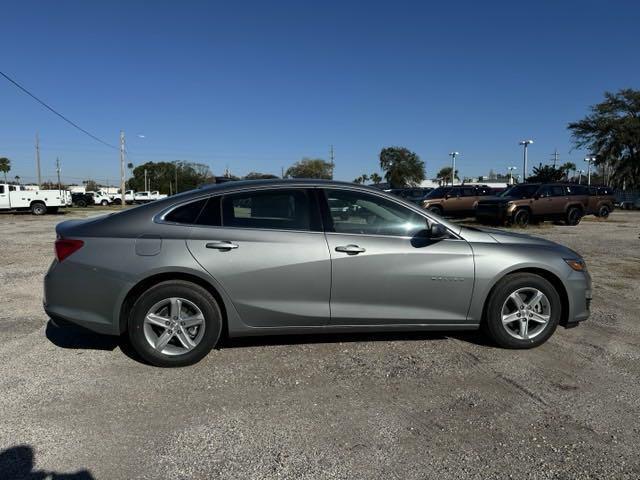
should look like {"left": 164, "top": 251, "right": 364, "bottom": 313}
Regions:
{"left": 0, "top": 0, "right": 640, "bottom": 182}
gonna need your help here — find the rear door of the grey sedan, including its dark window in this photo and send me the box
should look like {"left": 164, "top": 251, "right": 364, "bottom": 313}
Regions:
{"left": 187, "top": 188, "right": 331, "bottom": 327}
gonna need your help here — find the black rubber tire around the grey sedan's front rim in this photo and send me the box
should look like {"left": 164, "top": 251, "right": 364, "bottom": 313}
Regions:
{"left": 482, "top": 273, "right": 562, "bottom": 349}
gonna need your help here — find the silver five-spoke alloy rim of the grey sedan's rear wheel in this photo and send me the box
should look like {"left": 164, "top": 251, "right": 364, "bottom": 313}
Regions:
{"left": 144, "top": 297, "right": 205, "bottom": 355}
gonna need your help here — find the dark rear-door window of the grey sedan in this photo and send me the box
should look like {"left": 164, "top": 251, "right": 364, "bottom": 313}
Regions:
{"left": 222, "top": 189, "right": 311, "bottom": 230}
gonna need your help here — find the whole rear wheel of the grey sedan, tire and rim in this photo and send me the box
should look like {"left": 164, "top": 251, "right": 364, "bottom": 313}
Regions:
{"left": 128, "top": 280, "right": 222, "bottom": 367}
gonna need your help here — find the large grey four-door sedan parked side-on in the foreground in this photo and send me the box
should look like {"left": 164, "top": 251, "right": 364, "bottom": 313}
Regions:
{"left": 44, "top": 180, "right": 591, "bottom": 367}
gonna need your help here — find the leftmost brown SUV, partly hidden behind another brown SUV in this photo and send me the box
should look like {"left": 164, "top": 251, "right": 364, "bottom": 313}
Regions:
{"left": 422, "top": 185, "right": 494, "bottom": 217}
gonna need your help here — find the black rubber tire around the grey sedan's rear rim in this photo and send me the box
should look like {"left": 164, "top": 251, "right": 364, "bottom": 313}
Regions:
{"left": 128, "top": 280, "right": 222, "bottom": 367}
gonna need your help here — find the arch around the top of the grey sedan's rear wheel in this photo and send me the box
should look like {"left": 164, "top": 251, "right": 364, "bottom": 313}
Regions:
{"left": 118, "top": 272, "right": 229, "bottom": 336}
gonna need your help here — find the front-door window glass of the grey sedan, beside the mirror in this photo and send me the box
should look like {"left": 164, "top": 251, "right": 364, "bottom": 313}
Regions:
{"left": 325, "top": 190, "right": 427, "bottom": 237}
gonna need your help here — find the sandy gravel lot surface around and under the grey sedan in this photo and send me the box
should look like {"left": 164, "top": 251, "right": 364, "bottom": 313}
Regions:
{"left": 0, "top": 212, "right": 640, "bottom": 479}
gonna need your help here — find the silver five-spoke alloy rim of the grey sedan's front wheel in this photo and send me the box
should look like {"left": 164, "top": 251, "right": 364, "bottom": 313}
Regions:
{"left": 501, "top": 287, "right": 551, "bottom": 340}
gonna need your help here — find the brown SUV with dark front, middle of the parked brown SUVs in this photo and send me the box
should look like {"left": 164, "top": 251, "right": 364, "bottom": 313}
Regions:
{"left": 476, "top": 183, "right": 593, "bottom": 227}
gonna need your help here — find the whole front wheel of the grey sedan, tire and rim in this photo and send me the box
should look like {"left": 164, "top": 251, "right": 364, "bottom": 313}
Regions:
{"left": 483, "top": 273, "right": 562, "bottom": 348}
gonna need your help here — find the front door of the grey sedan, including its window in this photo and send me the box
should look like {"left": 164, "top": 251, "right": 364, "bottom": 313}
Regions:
{"left": 320, "top": 188, "right": 474, "bottom": 325}
